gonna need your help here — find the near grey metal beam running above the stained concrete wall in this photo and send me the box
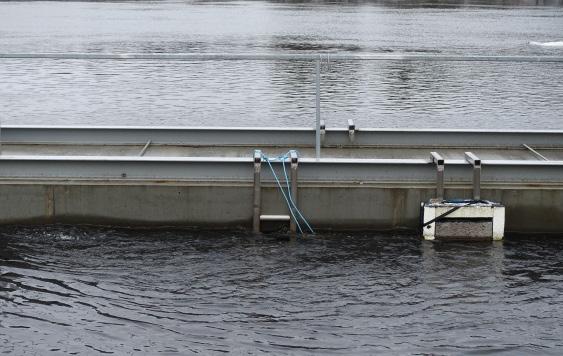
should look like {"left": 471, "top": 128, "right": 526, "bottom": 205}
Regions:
{"left": 0, "top": 156, "right": 563, "bottom": 188}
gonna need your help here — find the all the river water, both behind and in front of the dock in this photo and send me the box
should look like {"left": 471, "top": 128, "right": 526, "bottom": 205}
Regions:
{"left": 0, "top": 1, "right": 563, "bottom": 355}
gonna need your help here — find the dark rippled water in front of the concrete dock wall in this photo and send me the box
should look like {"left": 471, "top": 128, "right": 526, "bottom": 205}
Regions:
{"left": 0, "top": 227, "right": 563, "bottom": 355}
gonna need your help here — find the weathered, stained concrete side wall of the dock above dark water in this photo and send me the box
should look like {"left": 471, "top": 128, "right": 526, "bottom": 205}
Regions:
{"left": 0, "top": 182, "right": 563, "bottom": 233}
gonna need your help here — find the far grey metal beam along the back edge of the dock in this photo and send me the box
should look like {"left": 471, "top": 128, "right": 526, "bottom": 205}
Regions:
{"left": 2, "top": 125, "right": 563, "bottom": 149}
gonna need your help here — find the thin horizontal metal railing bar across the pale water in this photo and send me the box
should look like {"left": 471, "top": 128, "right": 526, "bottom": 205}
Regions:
{"left": 0, "top": 53, "right": 563, "bottom": 63}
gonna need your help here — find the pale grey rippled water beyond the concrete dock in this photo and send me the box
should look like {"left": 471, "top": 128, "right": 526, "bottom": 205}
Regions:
{"left": 0, "top": 0, "right": 563, "bottom": 129}
